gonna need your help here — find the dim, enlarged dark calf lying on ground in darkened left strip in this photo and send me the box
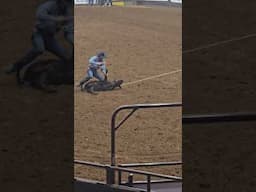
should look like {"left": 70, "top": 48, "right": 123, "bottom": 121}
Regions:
{"left": 17, "top": 59, "right": 74, "bottom": 92}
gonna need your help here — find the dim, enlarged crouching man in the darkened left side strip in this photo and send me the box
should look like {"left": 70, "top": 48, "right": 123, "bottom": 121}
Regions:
{"left": 5, "top": 0, "right": 73, "bottom": 80}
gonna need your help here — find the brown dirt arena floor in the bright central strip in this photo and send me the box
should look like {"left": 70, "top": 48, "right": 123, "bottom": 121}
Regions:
{"left": 74, "top": 6, "right": 182, "bottom": 179}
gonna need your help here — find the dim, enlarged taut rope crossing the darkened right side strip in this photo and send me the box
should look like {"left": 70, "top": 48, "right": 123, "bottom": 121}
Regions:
{"left": 182, "top": 33, "right": 256, "bottom": 54}
